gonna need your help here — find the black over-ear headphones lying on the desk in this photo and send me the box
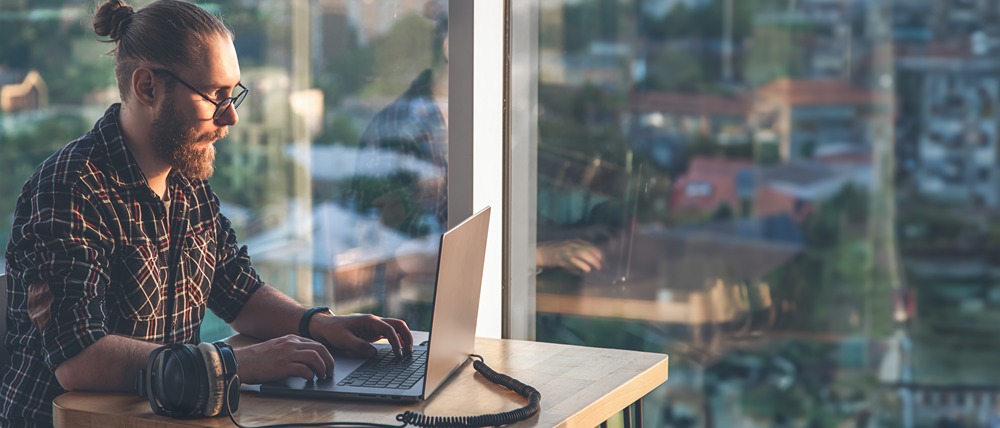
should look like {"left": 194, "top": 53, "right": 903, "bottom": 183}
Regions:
{"left": 136, "top": 342, "right": 240, "bottom": 418}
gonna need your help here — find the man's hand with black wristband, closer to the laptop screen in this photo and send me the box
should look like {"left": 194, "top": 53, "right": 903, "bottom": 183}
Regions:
{"left": 309, "top": 314, "right": 413, "bottom": 357}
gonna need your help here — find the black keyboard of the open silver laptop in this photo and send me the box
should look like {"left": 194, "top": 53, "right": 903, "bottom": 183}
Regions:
{"left": 337, "top": 348, "right": 427, "bottom": 389}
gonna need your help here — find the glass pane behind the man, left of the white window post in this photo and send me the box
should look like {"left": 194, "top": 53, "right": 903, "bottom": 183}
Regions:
{"left": 0, "top": 0, "right": 448, "bottom": 340}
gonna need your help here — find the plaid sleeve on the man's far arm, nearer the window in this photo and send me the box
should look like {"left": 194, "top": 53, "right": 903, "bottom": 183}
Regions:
{"left": 208, "top": 209, "right": 264, "bottom": 323}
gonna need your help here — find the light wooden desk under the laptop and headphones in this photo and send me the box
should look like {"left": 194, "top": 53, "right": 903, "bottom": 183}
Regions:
{"left": 52, "top": 338, "right": 667, "bottom": 428}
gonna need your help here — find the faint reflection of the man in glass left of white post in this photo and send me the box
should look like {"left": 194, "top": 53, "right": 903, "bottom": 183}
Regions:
{"left": 336, "top": 0, "right": 448, "bottom": 323}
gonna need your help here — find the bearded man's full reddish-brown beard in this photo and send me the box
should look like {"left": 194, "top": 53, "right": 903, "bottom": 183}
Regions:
{"left": 153, "top": 103, "right": 227, "bottom": 180}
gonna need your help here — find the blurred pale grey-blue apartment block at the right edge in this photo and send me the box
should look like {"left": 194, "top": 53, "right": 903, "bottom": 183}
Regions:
{"left": 897, "top": 46, "right": 1000, "bottom": 207}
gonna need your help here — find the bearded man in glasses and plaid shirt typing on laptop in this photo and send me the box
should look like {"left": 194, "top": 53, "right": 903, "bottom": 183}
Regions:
{"left": 0, "top": 0, "right": 412, "bottom": 426}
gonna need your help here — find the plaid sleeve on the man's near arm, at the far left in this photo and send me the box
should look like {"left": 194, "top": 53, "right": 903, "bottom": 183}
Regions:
{"left": 9, "top": 180, "right": 114, "bottom": 370}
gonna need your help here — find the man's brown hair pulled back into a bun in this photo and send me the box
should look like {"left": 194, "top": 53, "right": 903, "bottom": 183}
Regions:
{"left": 94, "top": 0, "right": 233, "bottom": 100}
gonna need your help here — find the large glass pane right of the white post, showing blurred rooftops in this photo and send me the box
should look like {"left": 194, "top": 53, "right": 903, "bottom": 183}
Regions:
{"left": 511, "top": 0, "right": 1000, "bottom": 427}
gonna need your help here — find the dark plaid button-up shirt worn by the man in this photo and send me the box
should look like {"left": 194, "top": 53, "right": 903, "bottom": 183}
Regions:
{"left": 0, "top": 104, "right": 262, "bottom": 426}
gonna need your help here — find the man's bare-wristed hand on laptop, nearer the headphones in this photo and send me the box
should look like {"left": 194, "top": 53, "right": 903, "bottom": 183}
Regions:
{"left": 234, "top": 334, "right": 333, "bottom": 384}
